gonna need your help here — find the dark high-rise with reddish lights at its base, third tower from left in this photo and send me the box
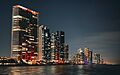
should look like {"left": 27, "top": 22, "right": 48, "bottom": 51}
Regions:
{"left": 51, "top": 31, "right": 65, "bottom": 63}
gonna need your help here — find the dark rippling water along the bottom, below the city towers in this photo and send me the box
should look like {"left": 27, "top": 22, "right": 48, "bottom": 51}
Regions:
{"left": 0, "top": 65, "right": 120, "bottom": 75}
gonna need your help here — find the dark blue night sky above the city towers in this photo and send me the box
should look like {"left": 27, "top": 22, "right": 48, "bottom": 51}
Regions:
{"left": 0, "top": 0, "right": 120, "bottom": 64}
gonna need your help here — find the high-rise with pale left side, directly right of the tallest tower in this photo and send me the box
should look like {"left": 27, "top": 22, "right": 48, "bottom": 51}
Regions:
{"left": 38, "top": 25, "right": 51, "bottom": 63}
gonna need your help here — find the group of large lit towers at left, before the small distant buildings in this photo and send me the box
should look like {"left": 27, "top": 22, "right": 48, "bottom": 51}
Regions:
{"left": 11, "top": 5, "right": 69, "bottom": 64}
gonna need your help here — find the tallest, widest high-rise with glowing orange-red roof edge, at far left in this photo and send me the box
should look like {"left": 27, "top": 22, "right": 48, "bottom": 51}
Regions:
{"left": 11, "top": 5, "right": 39, "bottom": 60}
